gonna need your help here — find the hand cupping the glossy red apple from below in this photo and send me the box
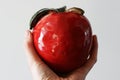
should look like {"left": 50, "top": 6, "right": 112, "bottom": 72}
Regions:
{"left": 25, "top": 30, "right": 98, "bottom": 80}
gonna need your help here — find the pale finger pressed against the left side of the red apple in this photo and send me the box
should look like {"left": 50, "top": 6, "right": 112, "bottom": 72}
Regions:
{"left": 25, "top": 30, "right": 40, "bottom": 65}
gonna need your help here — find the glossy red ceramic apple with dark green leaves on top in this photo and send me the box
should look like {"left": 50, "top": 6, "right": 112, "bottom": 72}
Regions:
{"left": 31, "top": 7, "right": 92, "bottom": 73}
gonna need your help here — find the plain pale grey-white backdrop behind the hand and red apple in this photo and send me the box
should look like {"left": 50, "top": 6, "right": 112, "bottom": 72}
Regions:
{"left": 0, "top": 0, "right": 120, "bottom": 80}
